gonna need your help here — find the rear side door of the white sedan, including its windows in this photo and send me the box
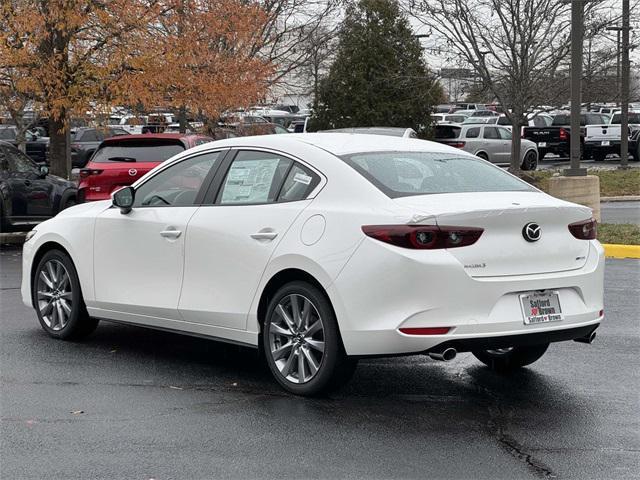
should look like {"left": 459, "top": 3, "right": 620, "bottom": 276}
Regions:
{"left": 179, "top": 150, "right": 320, "bottom": 330}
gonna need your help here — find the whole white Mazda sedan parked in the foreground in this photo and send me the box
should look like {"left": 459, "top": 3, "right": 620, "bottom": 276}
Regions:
{"left": 22, "top": 133, "right": 604, "bottom": 395}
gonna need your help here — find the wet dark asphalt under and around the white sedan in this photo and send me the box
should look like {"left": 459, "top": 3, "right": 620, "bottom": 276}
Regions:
{"left": 0, "top": 248, "right": 640, "bottom": 480}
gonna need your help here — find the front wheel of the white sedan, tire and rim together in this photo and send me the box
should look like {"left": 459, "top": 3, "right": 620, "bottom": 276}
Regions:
{"left": 31, "top": 250, "right": 98, "bottom": 340}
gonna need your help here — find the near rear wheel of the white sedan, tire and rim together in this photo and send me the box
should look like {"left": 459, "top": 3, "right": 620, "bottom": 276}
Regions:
{"left": 262, "top": 281, "right": 357, "bottom": 396}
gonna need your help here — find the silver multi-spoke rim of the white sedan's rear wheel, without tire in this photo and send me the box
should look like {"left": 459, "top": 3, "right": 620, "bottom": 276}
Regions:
{"left": 268, "top": 294, "right": 325, "bottom": 383}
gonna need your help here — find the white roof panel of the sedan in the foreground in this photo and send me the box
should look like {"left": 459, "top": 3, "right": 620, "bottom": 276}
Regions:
{"left": 190, "top": 132, "right": 465, "bottom": 156}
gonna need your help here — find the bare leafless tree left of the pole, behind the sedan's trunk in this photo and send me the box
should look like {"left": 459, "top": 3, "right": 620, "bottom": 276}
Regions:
{"left": 408, "top": 0, "right": 628, "bottom": 173}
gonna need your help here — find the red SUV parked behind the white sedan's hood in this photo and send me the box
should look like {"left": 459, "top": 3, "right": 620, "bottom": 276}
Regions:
{"left": 78, "top": 133, "right": 213, "bottom": 202}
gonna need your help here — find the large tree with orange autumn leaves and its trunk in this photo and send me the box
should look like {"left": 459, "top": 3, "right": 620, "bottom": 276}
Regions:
{"left": 0, "top": 0, "right": 271, "bottom": 177}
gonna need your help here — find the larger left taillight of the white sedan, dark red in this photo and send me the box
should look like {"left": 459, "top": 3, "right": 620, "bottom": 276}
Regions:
{"left": 362, "top": 225, "right": 484, "bottom": 250}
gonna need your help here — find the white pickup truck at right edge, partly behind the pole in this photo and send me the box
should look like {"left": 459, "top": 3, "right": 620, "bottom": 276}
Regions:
{"left": 584, "top": 111, "right": 640, "bottom": 162}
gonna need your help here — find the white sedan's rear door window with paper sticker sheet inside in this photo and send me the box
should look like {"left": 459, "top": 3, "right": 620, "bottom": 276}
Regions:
{"left": 218, "top": 151, "right": 292, "bottom": 205}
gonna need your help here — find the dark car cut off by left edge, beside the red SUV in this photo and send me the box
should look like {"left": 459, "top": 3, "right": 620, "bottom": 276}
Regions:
{"left": 0, "top": 141, "right": 77, "bottom": 232}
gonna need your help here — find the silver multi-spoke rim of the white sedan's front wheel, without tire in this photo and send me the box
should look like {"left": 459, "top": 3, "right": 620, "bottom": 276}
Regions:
{"left": 36, "top": 259, "right": 73, "bottom": 331}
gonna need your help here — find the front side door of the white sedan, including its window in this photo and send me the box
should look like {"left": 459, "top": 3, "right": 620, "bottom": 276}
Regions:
{"left": 90, "top": 152, "right": 220, "bottom": 323}
